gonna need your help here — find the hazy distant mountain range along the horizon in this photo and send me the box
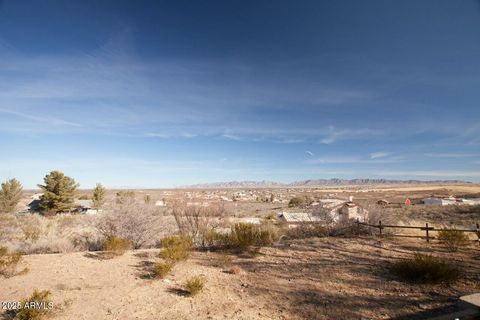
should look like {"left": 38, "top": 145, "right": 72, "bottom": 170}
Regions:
{"left": 182, "top": 178, "right": 471, "bottom": 189}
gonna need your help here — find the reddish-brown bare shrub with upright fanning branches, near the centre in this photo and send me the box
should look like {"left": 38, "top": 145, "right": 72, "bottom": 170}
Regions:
{"left": 169, "top": 201, "right": 226, "bottom": 244}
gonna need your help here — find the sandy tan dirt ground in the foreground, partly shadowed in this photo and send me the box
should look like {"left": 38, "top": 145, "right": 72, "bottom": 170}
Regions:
{"left": 0, "top": 237, "right": 480, "bottom": 320}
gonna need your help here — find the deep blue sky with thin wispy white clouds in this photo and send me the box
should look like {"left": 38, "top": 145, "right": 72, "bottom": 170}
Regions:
{"left": 0, "top": 0, "right": 480, "bottom": 188}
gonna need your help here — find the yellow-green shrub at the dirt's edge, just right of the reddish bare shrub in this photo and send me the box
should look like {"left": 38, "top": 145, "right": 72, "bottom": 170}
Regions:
{"left": 226, "top": 223, "right": 278, "bottom": 250}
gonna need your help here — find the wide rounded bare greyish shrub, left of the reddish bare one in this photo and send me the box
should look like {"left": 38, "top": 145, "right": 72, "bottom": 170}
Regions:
{"left": 95, "top": 199, "right": 162, "bottom": 249}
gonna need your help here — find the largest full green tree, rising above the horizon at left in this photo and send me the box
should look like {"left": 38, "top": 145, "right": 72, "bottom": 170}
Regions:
{"left": 38, "top": 171, "right": 79, "bottom": 214}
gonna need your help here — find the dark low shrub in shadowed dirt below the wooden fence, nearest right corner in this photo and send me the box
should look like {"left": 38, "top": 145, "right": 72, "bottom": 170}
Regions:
{"left": 391, "top": 253, "right": 459, "bottom": 284}
